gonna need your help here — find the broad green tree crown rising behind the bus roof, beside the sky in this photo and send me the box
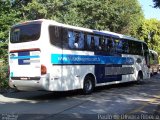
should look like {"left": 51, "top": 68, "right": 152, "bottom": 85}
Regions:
{"left": 21, "top": 0, "right": 144, "bottom": 35}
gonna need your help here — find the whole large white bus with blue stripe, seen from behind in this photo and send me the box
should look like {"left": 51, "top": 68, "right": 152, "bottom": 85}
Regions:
{"left": 9, "top": 19, "right": 150, "bottom": 94}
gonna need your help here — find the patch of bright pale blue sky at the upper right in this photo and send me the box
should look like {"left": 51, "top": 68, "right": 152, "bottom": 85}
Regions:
{"left": 138, "top": 0, "right": 160, "bottom": 20}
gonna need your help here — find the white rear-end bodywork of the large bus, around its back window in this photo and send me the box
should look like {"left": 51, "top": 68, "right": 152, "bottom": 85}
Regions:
{"left": 9, "top": 21, "right": 49, "bottom": 91}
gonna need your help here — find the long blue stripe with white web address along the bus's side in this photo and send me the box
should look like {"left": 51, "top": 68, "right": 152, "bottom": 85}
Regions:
{"left": 51, "top": 54, "right": 134, "bottom": 65}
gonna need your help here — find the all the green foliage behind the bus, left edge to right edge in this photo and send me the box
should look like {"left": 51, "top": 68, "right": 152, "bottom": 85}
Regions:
{"left": 0, "top": 0, "right": 160, "bottom": 88}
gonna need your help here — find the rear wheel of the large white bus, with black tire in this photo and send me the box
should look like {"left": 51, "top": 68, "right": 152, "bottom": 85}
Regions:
{"left": 83, "top": 75, "right": 95, "bottom": 95}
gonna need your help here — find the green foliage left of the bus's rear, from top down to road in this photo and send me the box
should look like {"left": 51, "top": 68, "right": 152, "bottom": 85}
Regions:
{"left": 0, "top": 0, "right": 21, "bottom": 88}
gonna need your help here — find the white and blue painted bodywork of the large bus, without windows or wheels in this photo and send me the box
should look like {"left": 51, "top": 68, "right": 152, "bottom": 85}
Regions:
{"left": 9, "top": 20, "right": 149, "bottom": 91}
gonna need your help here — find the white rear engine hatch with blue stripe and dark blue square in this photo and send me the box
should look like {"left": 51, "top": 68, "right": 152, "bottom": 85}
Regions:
{"left": 10, "top": 50, "right": 41, "bottom": 79}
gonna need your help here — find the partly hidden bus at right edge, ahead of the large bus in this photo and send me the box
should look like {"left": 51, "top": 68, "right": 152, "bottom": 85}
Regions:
{"left": 149, "top": 50, "right": 159, "bottom": 76}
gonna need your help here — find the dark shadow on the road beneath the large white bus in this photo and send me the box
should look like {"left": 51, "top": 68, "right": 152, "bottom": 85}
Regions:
{"left": 3, "top": 82, "right": 146, "bottom": 101}
